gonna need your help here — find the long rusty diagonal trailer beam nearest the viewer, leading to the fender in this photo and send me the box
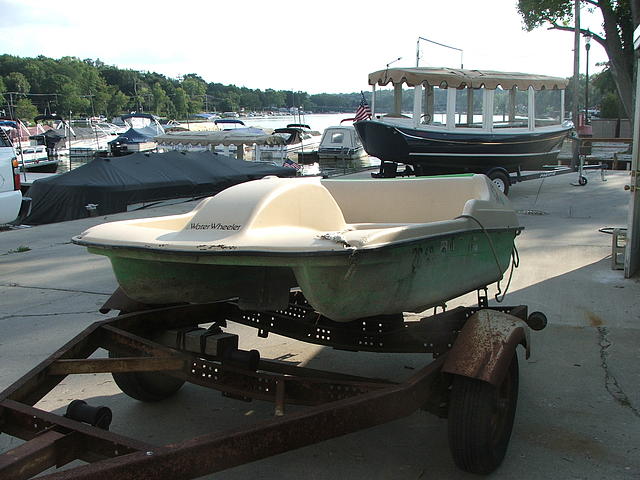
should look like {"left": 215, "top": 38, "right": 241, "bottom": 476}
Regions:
{"left": 5, "top": 357, "right": 444, "bottom": 480}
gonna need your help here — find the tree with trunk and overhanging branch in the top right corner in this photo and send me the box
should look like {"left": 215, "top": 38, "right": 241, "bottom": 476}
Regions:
{"left": 518, "top": 0, "right": 640, "bottom": 118}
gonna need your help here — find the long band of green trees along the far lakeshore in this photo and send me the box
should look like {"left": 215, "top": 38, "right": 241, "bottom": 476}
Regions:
{"left": 0, "top": 55, "right": 378, "bottom": 121}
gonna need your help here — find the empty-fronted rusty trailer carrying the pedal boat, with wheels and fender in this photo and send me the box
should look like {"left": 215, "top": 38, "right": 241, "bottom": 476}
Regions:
{"left": 0, "top": 289, "right": 546, "bottom": 480}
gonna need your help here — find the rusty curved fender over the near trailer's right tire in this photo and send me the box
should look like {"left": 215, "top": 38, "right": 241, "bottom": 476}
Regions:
{"left": 442, "top": 309, "right": 530, "bottom": 386}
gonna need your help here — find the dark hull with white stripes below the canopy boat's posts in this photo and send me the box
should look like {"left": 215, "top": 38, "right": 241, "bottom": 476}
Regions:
{"left": 355, "top": 120, "right": 570, "bottom": 173}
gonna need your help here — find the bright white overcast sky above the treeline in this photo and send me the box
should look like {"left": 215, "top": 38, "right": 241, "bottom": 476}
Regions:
{"left": 0, "top": 0, "right": 606, "bottom": 93}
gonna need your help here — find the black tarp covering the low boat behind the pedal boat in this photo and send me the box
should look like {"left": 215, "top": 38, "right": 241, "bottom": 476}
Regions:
{"left": 23, "top": 151, "right": 295, "bottom": 225}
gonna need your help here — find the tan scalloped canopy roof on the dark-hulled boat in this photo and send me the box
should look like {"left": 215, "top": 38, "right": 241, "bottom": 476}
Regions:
{"left": 369, "top": 67, "right": 569, "bottom": 90}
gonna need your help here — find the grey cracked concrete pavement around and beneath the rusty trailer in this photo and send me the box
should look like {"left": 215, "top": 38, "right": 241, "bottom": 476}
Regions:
{"left": 0, "top": 173, "right": 640, "bottom": 480}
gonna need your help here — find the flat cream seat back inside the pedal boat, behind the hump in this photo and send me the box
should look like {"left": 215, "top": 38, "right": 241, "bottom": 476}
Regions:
{"left": 322, "top": 175, "right": 492, "bottom": 223}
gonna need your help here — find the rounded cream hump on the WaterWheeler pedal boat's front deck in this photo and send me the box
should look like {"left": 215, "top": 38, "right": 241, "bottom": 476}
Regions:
{"left": 183, "top": 178, "right": 346, "bottom": 238}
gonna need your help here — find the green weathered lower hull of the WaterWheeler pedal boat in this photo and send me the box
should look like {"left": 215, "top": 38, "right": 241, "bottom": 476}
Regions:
{"left": 89, "top": 228, "right": 518, "bottom": 322}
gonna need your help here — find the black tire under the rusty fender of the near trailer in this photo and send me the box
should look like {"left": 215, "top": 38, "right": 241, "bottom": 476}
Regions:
{"left": 448, "top": 353, "right": 518, "bottom": 474}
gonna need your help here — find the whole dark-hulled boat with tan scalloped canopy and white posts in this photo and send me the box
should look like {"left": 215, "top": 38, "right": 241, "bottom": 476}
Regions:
{"left": 355, "top": 67, "right": 573, "bottom": 188}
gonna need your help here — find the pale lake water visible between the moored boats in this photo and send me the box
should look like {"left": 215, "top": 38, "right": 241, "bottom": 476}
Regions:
{"left": 57, "top": 113, "right": 380, "bottom": 175}
